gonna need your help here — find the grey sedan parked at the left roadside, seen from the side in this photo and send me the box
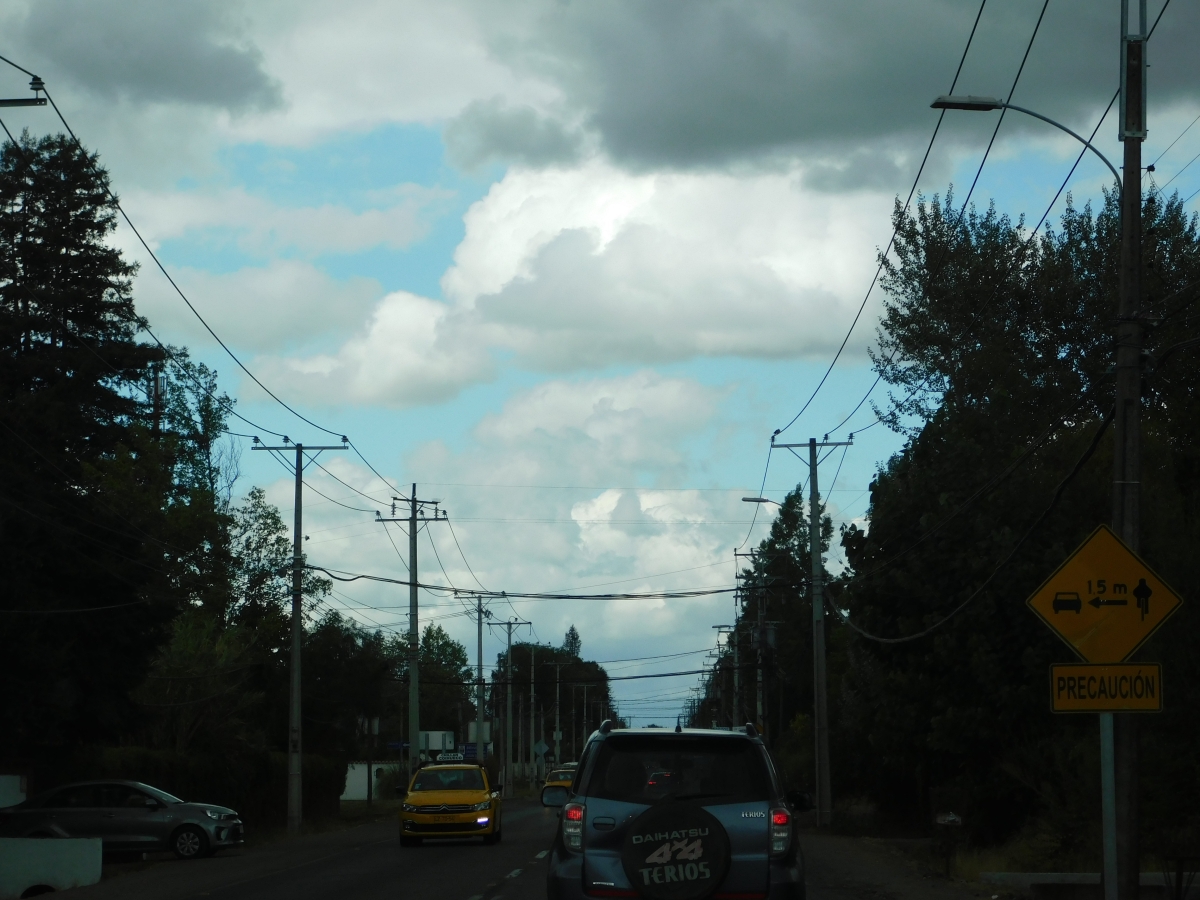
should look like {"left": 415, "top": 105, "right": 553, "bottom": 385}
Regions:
{"left": 0, "top": 781, "right": 244, "bottom": 859}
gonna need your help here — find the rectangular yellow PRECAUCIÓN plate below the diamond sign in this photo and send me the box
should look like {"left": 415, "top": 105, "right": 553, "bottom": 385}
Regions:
{"left": 1050, "top": 662, "right": 1163, "bottom": 713}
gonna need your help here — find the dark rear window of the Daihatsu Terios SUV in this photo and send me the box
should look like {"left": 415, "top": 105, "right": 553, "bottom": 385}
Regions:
{"left": 587, "top": 734, "right": 770, "bottom": 803}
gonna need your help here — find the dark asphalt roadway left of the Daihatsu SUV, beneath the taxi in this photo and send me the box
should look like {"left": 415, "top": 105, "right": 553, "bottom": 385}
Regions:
{"left": 70, "top": 803, "right": 558, "bottom": 900}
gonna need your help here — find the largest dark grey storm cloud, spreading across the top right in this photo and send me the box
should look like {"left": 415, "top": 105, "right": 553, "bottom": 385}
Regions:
{"left": 482, "top": 0, "right": 1200, "bottom": 168}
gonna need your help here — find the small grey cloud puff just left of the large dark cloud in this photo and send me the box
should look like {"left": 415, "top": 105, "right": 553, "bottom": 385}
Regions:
{"left": 445, "top": 98, "right": 580, "bottom": 169}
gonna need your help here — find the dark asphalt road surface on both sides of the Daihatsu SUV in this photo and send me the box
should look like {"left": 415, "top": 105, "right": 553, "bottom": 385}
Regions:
{"left": 71, "top": 802, "right": 991, "bottom": 900}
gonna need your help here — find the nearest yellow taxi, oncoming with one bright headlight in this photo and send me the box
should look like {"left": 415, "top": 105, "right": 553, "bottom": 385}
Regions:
{"left": 400, "top": 763, "right": 502, "bottom": 847}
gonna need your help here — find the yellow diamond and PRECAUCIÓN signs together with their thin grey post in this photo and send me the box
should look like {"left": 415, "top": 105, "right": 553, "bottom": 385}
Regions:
{"left": 1026, "top": 526, "right": 1183, "bottom": 900}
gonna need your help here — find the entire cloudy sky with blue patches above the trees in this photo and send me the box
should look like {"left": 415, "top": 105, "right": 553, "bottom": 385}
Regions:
{"left": 0, "top": 0, "right": 1200, "bottom": 725}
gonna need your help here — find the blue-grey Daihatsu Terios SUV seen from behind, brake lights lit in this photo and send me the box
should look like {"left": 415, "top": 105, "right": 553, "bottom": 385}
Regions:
{"left": 542, "top": 721, "right": 811, "bottom": 900}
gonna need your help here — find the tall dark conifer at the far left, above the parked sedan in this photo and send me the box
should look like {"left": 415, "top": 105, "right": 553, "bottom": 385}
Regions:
{"left": 0, "top": 134, "right": 181, "bottom": 758}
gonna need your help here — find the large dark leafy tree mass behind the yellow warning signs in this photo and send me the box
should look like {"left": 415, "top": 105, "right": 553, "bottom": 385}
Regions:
{"left": 830, "top": 194, "right": 1200, "bottom": 864}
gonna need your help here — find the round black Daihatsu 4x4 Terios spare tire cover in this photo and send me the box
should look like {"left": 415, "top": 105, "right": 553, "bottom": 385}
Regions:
{"left": 620, "top": 800, "right": 730, "bottom": 900}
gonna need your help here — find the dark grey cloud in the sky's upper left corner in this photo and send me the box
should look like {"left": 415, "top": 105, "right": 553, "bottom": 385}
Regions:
{"left": 16, "top": 0, "right": 282, "bottom": 112}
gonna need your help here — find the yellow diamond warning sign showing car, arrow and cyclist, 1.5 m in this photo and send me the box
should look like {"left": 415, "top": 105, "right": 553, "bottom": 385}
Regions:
{"left": 1026, "top": 526, "right": 1182, "bottom": 662}
